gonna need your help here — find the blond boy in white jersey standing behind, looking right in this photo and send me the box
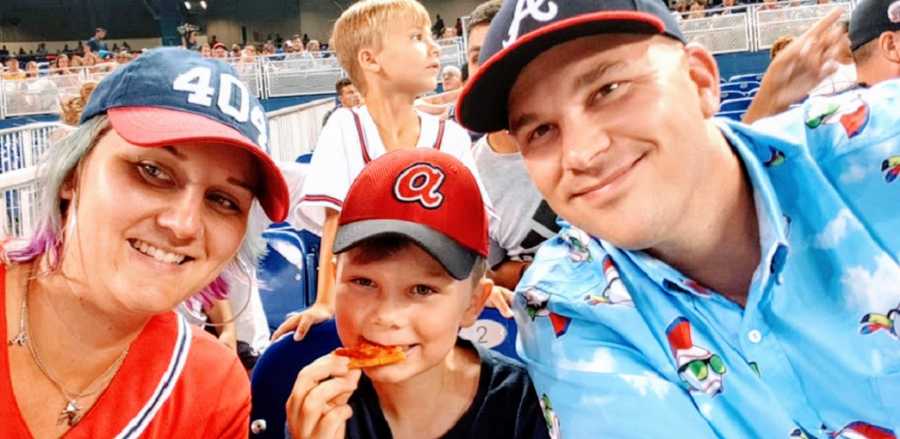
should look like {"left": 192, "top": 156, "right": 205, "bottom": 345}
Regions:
{"left": 273, "top": 0, "right": 487, "bottom": 339}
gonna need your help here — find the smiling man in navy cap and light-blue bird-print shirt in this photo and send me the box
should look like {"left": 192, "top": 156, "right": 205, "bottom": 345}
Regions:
{"left": 457, "top": 0, "right": 900, "bottom": 438}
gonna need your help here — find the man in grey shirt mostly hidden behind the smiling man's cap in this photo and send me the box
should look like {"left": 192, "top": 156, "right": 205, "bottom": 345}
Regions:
{"left": 467, "top": 0, "right": 559, "bottom": 296}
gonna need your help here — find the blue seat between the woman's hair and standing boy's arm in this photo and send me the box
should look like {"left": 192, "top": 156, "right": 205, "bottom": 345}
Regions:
{"left": 258, "top": 229, "right": 319, "bottom": 331}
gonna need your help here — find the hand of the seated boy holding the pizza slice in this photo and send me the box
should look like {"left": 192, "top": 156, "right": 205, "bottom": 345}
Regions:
{"left": 285, "top": 354, "right": 361, "bottom": 439}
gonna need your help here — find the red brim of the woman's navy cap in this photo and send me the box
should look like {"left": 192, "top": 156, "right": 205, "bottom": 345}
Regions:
{"left": 107, "top": 107, "right": 290, "bottom": 222}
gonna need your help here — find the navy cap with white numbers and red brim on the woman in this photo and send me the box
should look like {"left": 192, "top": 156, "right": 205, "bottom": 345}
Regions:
{"left": 81, "top": 47, "right": 290, "bottom": 222}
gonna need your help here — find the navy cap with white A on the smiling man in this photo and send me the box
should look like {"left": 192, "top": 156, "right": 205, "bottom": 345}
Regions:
{"left": 456, "top": 0, "right": 685, "bottom": 133}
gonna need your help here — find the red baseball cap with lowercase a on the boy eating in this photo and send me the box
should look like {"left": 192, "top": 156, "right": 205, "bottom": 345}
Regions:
{"left": 334, "top": 148, "right": 488, "bottom": 280}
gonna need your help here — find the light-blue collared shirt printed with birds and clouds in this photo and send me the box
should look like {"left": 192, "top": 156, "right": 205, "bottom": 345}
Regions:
{"left": 515, "top": 81, "right": 900, "bottom": 438}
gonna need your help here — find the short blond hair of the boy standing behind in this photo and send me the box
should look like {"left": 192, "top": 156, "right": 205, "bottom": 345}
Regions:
{"left": 331, "top": 0, "right": 431, "bottom": 91}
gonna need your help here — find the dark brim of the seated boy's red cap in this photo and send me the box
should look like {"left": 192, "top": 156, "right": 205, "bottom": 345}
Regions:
{"left": 333, "top": 220, "right": 478, "bottom": 280}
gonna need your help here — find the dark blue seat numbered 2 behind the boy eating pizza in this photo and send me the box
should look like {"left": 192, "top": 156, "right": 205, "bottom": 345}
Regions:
{"left": 250, "top": 308, "right": 518, "bottom": 439}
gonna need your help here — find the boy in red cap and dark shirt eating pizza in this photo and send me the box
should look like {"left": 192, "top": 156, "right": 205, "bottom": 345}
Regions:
{"left": 287, "top": 148, "right": 548, "bottom": 439}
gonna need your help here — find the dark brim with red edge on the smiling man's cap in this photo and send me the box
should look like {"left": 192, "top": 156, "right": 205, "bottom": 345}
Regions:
{"left": 456, "top": 11, "right": 664, "bottom": 133}
